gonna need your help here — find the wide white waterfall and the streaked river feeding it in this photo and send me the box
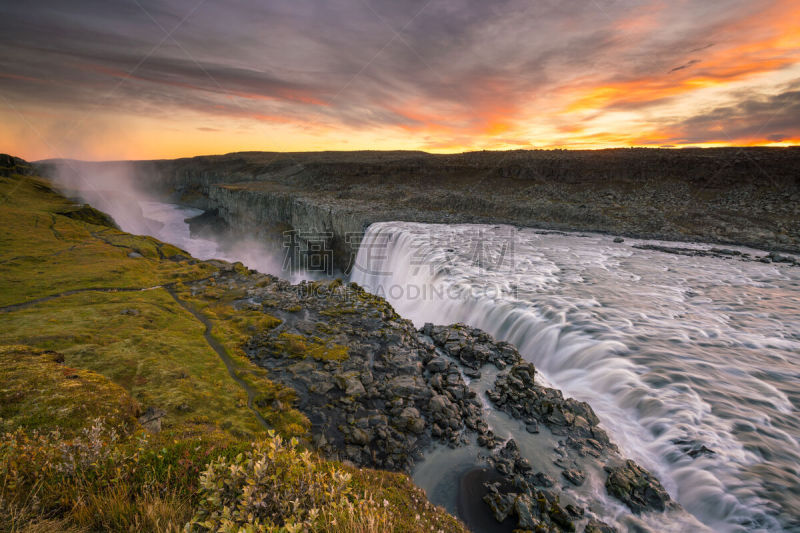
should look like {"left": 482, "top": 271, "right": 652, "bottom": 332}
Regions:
{"left": 352, "top": 222, "right": 800, "bottom": 531}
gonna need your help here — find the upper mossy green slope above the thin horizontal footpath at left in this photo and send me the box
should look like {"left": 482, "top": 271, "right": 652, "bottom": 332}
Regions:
{"left": 0, "top": 177, "right": 216, "bottom": 306}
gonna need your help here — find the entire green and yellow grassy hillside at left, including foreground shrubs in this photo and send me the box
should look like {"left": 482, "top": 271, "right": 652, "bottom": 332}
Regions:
{"left": 0, "top": 168, "right": 463, "bottom": 532}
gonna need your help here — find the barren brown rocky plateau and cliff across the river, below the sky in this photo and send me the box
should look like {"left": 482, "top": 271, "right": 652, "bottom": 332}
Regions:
{"left": 39, "top": 148, "right": 800, "bottom": 268}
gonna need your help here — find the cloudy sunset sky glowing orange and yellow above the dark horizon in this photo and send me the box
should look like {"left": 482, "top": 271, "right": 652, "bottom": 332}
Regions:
{"left": 0, "top": 0, "right": 800, "bottom": 160}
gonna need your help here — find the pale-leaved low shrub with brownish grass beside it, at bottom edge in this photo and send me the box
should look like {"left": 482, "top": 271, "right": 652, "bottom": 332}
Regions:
{"left": 186, "top": 433, "right": 466, "bottom": 533}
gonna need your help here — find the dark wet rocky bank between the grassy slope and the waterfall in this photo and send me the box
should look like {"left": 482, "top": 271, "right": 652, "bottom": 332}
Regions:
{"left": 177, "top": 260, "right": 677, "bottom": 531}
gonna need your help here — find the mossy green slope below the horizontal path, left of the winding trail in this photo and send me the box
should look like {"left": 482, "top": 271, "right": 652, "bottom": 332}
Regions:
{"left": 0, "top": 289, "right": 268, "bottom": 433}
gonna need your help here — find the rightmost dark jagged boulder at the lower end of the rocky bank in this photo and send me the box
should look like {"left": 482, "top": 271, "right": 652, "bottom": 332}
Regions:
{"left": 606, "top": 459, "right": 677, "bottom": 514}
